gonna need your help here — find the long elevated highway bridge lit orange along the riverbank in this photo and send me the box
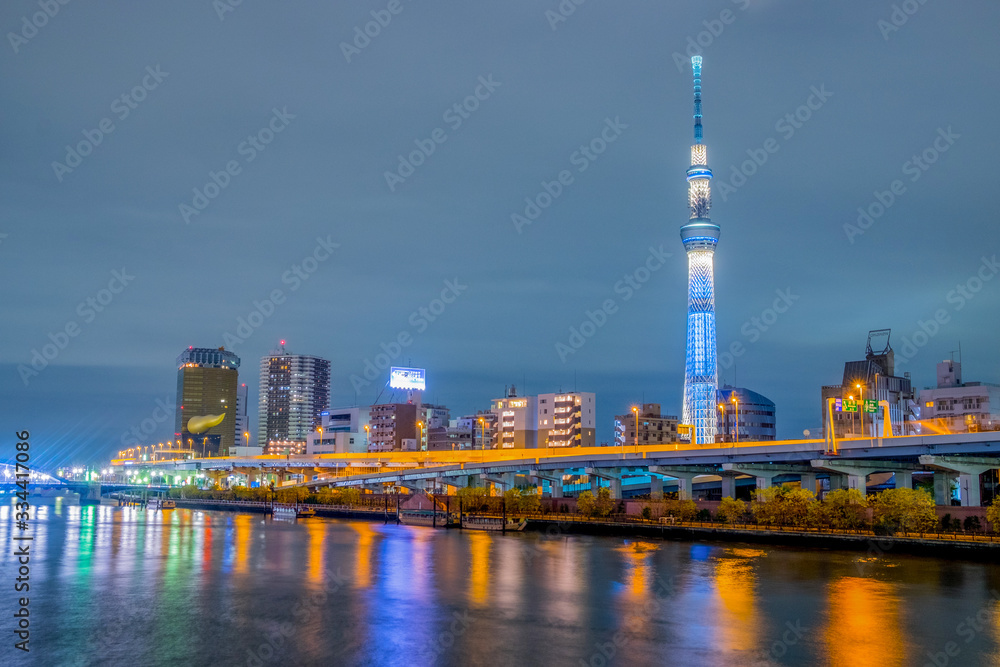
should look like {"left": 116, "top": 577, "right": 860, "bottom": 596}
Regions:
{"left": 113, "top": 432, "right": 1000, "bottom": 506}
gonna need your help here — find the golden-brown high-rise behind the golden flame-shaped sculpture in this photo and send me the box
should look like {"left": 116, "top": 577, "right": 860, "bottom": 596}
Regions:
{"left": 174, "top": 347, "right": 240, "bottom": 456}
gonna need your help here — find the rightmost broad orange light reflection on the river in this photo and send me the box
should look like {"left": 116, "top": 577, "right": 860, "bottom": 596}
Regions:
{"left": 825, "top": 577, "right": 908, "bottom": 667}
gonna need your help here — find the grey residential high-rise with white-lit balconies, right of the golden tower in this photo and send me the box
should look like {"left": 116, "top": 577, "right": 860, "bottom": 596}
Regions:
{"left": 257, "top": 341, "right": 330, "bottom": 448}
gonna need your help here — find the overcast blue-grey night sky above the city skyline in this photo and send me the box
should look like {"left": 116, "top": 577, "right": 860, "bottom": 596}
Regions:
{"left": 0, "top": 0, "right": 1000, "bottom": 467}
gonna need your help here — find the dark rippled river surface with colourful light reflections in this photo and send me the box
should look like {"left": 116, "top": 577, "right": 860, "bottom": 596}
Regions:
{"left": 0, "top": 506, "right": 1000, "bottom": 667}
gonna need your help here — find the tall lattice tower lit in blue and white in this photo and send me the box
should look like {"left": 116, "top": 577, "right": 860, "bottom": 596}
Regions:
{"left": 681, "top": 56, "right": 719, "bottom": 443}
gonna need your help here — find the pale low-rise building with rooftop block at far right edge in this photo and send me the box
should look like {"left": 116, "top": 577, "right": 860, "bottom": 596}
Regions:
{"left": 920, "top": 360, "right": 1000, "bottom": 435}
